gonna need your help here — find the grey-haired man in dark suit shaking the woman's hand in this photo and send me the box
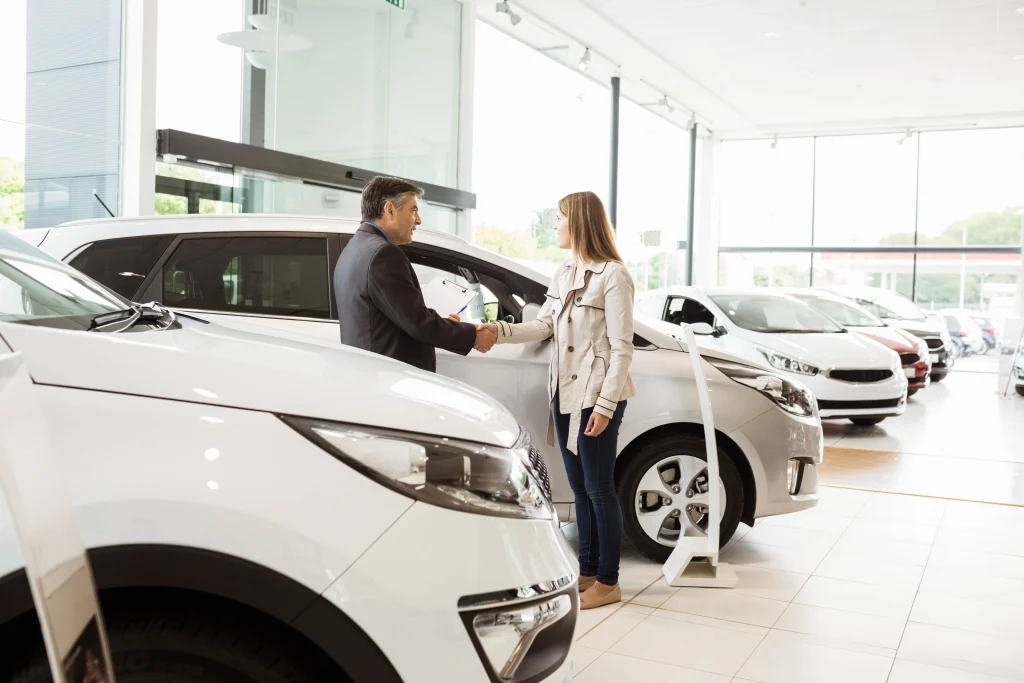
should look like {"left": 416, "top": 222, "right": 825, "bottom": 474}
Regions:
{"left": 334, "top": 176, "right": 495, "bottom": 372}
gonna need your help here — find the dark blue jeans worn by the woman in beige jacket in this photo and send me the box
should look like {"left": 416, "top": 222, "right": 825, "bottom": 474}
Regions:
{"left": 552, "top": 394, "right": 626, "bottom": 586}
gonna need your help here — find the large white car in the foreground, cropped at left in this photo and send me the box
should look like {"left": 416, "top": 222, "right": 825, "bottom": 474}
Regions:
{"left": 0, "top": 231, "right": 578, "bottom": 683}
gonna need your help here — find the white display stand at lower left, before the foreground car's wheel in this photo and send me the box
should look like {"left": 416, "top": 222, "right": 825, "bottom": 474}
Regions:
{"left": 0, "top": 352, "right": 114, "bottom": 683}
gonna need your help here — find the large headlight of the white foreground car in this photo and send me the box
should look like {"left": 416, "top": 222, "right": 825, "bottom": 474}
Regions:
{"left": 282, "top": 417, "right": 554, "bottom": 519}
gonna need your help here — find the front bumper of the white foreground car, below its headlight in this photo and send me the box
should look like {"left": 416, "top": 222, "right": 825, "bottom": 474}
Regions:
{"left": 324, "top": 503, "right": 579, "bottom": 683}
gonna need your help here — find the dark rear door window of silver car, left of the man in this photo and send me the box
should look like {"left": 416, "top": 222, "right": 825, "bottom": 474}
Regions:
{"left": 163, "top": 237, "right": 331, "bottom": 318}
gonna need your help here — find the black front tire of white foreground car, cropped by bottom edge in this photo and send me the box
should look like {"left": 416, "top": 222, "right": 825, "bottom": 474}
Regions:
{"left": 9, "top": 591, "right": 348, "bottom": 683}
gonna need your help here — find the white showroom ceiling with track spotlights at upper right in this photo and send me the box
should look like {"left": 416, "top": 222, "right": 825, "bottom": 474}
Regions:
{"left": 477, "top": 0, "right": 1024, "bottom": 139}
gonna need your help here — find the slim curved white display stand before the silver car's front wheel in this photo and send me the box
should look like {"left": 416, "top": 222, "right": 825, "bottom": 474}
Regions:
{"left": 662, "top": 325, "right": 738, "bottom": 588}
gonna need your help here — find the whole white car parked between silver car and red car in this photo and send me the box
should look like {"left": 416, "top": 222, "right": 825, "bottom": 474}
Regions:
{"left": 637, "top": 287, "right": 907, "bottom": 426}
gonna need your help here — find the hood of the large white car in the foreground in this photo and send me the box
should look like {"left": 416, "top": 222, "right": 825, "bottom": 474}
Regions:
{"left": 0, "top": 317, "right": 519, "bottom": 446}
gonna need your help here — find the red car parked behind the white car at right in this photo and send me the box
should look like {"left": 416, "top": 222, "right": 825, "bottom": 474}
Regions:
{"left": 786, "top": 290, "right": 932, "bottom": 397}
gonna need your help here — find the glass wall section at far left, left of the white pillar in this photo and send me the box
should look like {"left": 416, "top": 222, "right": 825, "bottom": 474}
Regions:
{"left": 0, "top": 0, "right": 121, "bottom": 229}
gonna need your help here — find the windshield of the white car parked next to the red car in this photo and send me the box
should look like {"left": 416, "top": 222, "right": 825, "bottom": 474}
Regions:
{"left": 712, "top": 294, "right": 845, "bottom": 334}
